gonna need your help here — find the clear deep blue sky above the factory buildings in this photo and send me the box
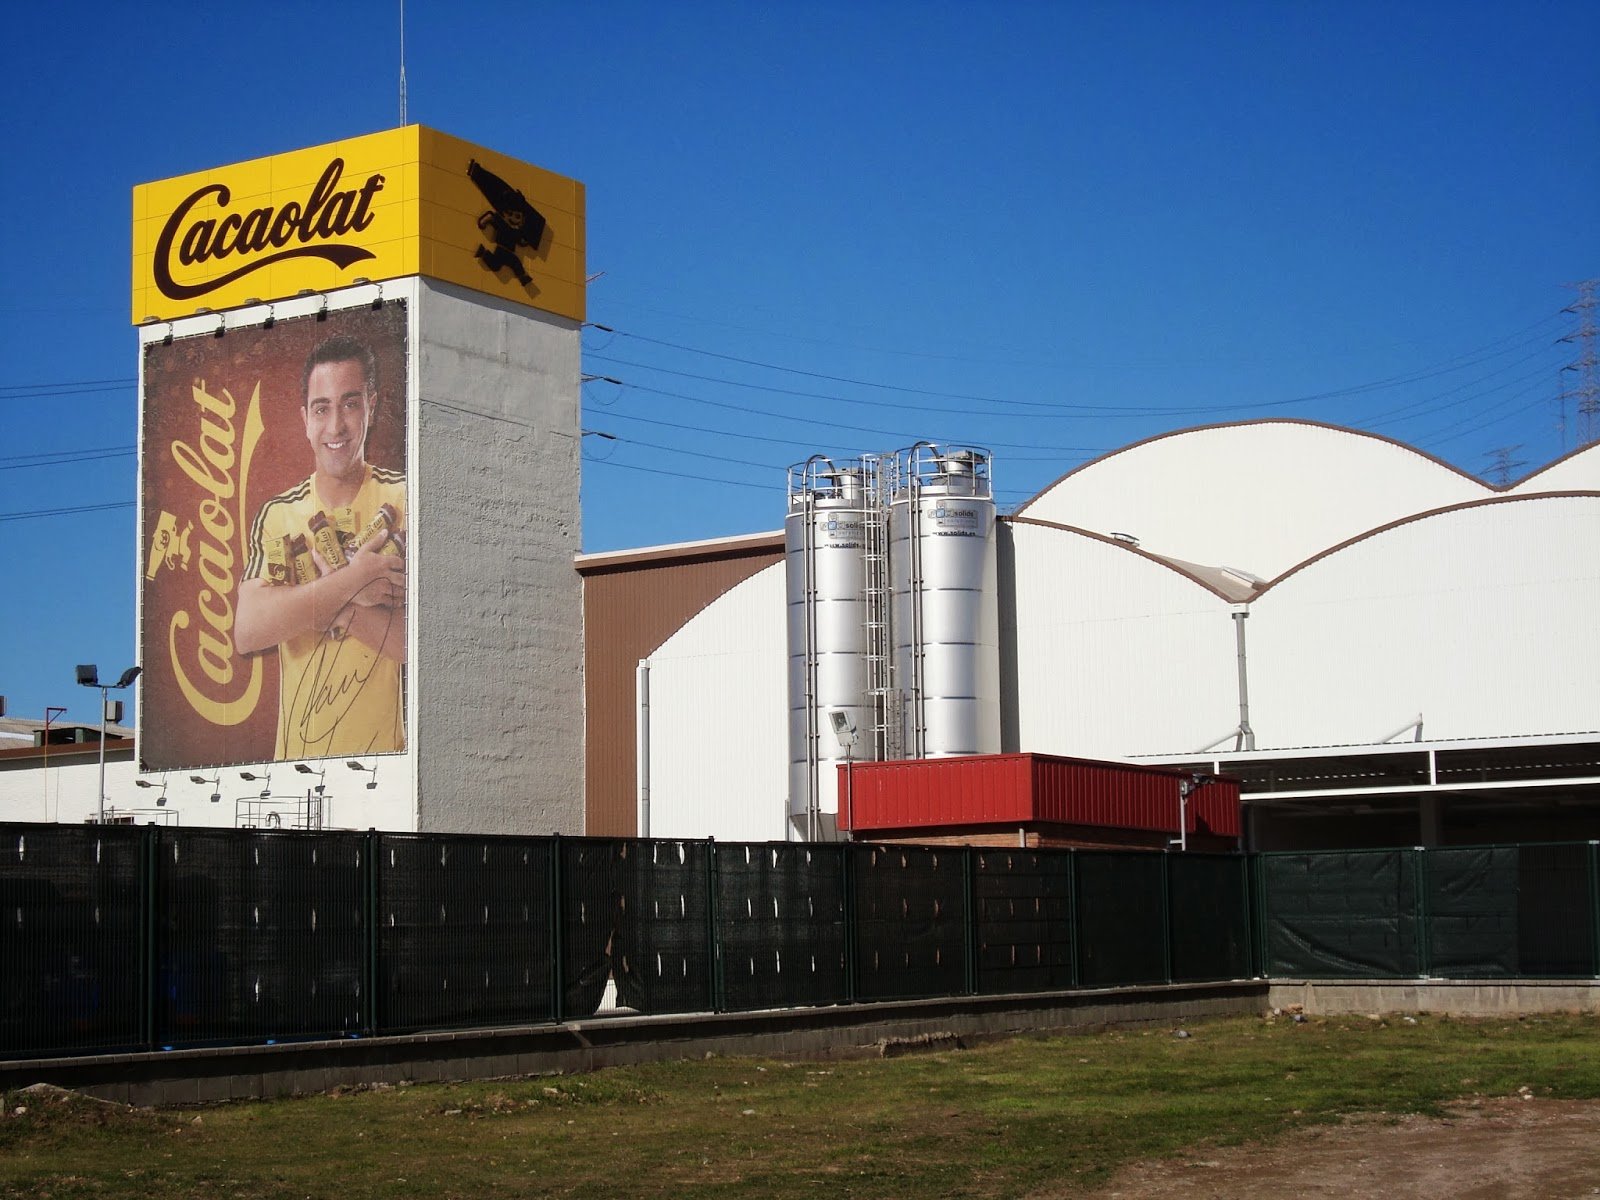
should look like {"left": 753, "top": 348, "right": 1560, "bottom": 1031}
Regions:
{"left": 0, "top": 0, "right": 1600, "bottom": 720}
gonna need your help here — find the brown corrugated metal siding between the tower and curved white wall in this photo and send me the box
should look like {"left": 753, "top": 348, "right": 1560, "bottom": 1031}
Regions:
{"left": 579, "top": 534, "right": 782, "bottom": 837}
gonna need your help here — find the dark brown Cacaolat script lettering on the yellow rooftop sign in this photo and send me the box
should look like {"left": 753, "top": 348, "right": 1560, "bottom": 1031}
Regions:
{"left": 150, "top": 158, "right": 384, "bottom": 299}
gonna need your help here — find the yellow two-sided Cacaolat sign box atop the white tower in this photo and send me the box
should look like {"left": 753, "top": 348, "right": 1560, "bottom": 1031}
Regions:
{"left": 133, "top": 125, "right": 584, "bottom": 325}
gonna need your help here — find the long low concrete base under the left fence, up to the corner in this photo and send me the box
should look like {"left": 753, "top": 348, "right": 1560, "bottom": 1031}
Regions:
{"left": 0, "top": 981, "right": 1267, "bottom": 1106}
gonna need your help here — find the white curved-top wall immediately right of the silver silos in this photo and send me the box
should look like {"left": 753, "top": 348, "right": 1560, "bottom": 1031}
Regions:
{"left": 1002, "top": 523, "right": 1238, "bottom": 757}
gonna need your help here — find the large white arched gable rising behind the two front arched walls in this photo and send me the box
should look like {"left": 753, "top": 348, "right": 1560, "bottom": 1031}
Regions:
{"left": 1018, "top": 419, "right": 1496, "bottom": 578}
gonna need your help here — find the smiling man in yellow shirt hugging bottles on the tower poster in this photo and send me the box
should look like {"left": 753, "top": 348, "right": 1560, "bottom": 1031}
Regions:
{"left": 235, "top": 333, "right": 406, "bottom": 760}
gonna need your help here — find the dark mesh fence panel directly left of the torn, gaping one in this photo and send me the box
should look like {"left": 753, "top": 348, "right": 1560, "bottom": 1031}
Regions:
{"left": 378, "top": 834, "right": 555, "bottom": 1032}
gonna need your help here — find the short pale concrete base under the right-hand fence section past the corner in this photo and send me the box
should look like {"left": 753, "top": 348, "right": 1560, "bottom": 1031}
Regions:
{"left": 1267, "top": 979, "right": 1600, "bottom": 1016}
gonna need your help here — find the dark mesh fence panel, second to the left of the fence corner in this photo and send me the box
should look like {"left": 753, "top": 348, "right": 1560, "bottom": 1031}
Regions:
{"left": 1074, "top": 850, "right": 1170, "bottom": 987}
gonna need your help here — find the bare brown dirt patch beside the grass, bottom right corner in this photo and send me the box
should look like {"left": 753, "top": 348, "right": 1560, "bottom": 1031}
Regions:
{"left": 1096, "top": 1099, "right": 1600, "bottom": 1200}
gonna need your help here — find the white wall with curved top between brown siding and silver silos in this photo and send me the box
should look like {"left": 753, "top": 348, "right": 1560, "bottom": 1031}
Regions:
{"left": 650, "top": 563, "right": 784, "bottom": 842}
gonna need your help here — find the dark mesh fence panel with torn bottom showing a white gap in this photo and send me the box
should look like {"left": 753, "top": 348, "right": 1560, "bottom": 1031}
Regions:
{"left": 562, "top": 838, "right": 712, "bottom": 1018}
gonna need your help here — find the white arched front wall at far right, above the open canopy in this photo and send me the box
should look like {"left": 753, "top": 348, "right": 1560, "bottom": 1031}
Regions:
{"left": 1250, "top": 496, "right": 1600, "bottom": 749}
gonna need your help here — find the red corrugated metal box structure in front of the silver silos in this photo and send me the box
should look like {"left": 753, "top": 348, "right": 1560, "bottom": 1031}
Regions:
{"left": 838, "top": 754, "right": 1238, "bottom": 837}
